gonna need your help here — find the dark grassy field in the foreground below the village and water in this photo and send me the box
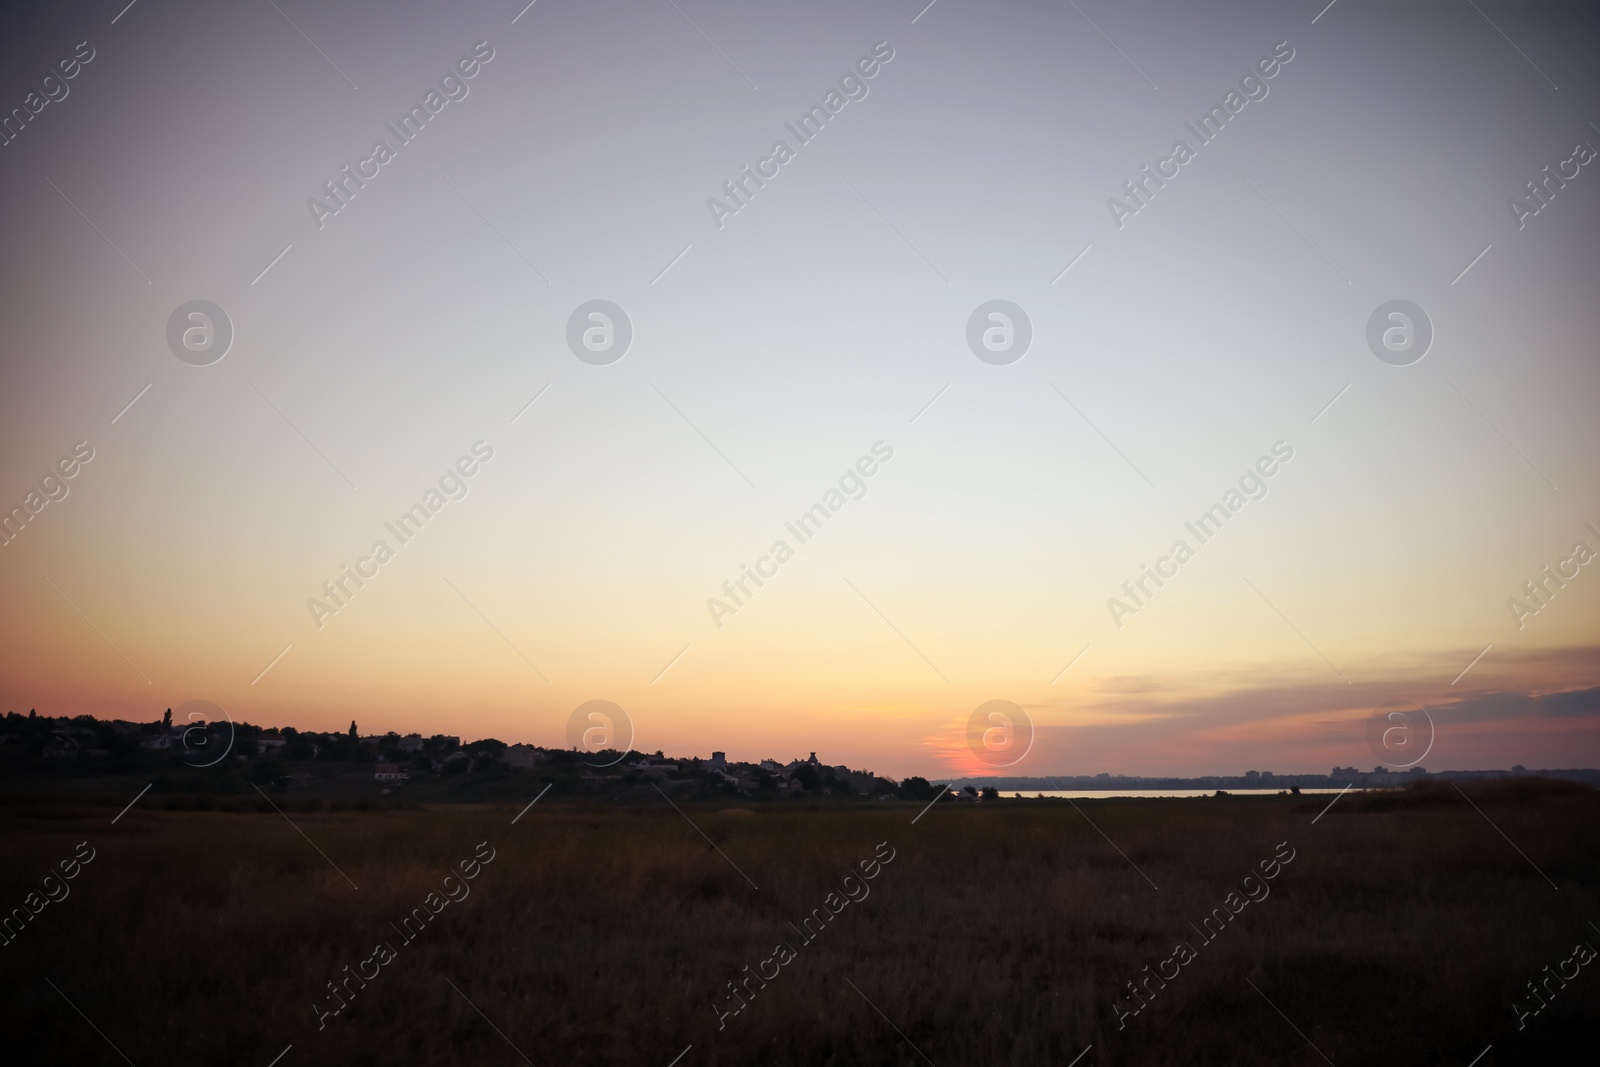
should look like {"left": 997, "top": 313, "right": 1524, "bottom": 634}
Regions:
{"left": 0, "top": 779, "right": 1600, "bottom": 1067}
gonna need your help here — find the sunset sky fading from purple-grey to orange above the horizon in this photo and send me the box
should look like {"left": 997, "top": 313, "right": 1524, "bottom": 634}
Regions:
{"left": 0, "top": 0, "right": 1600, "bottom": 776}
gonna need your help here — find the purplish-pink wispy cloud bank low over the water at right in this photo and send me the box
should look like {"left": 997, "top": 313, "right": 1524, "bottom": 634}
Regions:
{"left": 923, "top": 646, "right": 1600, "bottom": 776}
